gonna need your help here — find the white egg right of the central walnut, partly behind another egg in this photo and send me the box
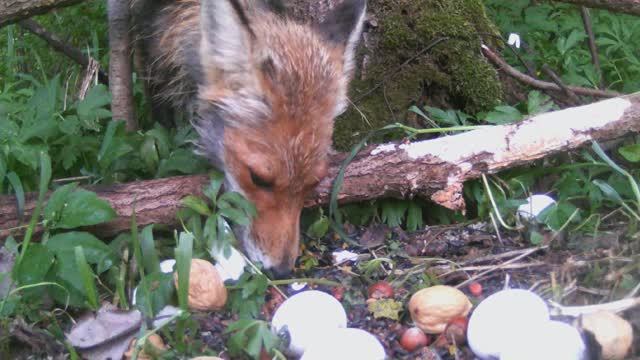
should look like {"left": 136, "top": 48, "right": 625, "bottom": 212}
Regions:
{"left": 467, "top": 289, "right": 549, "bottom": 360}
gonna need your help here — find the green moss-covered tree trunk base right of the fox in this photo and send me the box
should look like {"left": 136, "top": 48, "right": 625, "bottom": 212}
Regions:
{"left": 334, "top": 0, "right": 502, "bottom": 150}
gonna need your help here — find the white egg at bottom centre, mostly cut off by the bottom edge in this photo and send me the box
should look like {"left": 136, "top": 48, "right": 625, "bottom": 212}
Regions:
{"left": 300, "top": 328, "right": 387, "bottom": 360}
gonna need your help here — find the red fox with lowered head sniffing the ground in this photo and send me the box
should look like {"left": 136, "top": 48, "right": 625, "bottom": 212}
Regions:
{"left": 131, "top": 0, "right": 366, "bottom": 276}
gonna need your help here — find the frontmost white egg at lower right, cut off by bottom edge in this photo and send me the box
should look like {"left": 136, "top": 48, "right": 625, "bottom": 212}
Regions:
{"left": 500, "top": 320, "right": 586, "bottom": 360}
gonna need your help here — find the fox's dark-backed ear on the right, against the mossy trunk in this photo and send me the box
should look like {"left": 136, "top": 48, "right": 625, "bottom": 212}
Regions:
{"left": 317, "top": 0, "right": 367, "bottom": 76}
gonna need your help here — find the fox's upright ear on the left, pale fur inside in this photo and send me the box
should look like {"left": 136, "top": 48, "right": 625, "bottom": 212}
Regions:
{"left": 200, "top": 0, "right": 255, "bottom": 85}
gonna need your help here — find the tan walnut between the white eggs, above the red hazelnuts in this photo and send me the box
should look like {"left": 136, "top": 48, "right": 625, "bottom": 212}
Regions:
{"left": 409, "top": 285, "right": 472, "bottom": 334}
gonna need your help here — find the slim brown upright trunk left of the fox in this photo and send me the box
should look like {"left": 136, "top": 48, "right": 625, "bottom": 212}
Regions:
{"left": 107, "top": 0, "right": 138, "bottom": 131}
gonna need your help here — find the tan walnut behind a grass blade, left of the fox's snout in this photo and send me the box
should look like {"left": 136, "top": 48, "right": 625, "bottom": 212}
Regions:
{"left": 173, "top": 259, "right": 227, "bottom": 310}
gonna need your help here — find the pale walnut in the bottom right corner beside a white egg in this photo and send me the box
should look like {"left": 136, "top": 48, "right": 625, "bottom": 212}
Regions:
{"left": 581, "top": 311, "right": 633, "bottom": 360}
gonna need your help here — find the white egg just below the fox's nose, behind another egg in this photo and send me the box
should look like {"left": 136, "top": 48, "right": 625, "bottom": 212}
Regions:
{"left": 271, "top": 290, "right": 347, "bottom": 356}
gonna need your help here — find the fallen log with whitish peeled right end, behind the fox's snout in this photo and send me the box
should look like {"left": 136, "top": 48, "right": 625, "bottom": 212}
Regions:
{"left": 0, "top": 93, "right": 640, "bottom": 238}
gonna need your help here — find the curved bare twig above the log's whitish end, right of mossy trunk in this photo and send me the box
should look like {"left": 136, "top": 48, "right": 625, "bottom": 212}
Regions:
{"left": 482, "top": 45, "right": 621, "bottom": 98}
